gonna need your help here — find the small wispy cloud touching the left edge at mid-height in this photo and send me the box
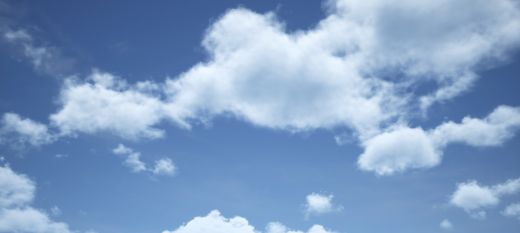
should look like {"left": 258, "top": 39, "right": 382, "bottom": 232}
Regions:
{"left": 0, "top": 113, "right": 56, "bottom": 148}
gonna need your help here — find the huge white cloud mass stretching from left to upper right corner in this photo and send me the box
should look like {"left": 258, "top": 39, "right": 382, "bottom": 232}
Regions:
{"left": 7, "top": 0, "right": 520, "bottom": 175}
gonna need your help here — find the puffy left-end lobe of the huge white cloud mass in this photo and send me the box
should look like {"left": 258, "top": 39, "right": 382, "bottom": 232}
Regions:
{"left": 50, "top": 71, "right": 164, "bottom": 139}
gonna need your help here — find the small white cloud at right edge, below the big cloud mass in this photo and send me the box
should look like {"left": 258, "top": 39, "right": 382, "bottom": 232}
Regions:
{"left": 450, "top": 178, "right": 520, "bottom": 219}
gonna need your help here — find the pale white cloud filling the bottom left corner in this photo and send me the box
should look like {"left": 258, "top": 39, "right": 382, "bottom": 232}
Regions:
{"left": 0, "top": 166, "right": 72, "bottom": 233}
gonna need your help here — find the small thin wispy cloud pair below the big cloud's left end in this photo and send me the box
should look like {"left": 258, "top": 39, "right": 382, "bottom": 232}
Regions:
{"left": 112, "top": 144, "right": 176, "bottom": 176}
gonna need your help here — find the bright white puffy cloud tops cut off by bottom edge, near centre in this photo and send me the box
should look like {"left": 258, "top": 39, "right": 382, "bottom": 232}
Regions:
{"left": 162, "top": 210, "right": 338, "bottom": 233}
